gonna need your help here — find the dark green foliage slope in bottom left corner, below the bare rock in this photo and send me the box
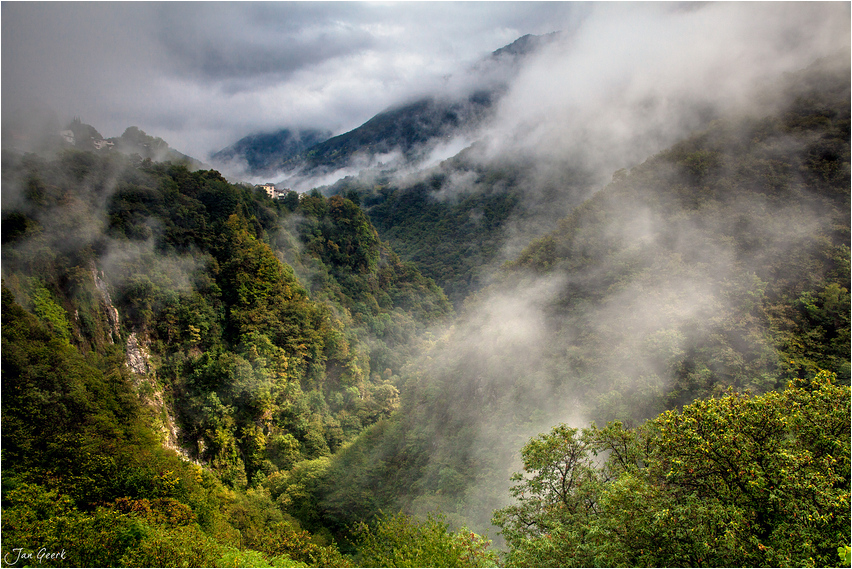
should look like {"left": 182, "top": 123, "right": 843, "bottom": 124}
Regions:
{"left": 0, "top": 286, "right": 347, "bottom": 567}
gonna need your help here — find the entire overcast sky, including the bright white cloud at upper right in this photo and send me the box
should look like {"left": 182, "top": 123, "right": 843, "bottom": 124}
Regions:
{"left": 2, "top": 1, "right": 850, "bottom": 164}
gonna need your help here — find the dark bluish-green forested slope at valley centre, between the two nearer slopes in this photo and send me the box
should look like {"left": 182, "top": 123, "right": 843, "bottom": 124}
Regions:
{"left": 322, "top": 139, "right": 596, "bottom": 308}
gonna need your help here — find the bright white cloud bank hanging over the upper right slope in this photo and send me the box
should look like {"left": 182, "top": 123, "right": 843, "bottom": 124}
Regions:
{"left": 470, "top": 2, "right": 850, "bottom": 191}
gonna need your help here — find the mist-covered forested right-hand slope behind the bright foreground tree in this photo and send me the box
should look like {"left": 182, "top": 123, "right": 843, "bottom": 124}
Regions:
{"left": 304, "top": 56, "right": 850, "bottom": 535}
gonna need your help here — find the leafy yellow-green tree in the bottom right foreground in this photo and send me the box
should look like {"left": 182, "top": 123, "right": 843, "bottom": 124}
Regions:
{"left": 493, "top": 372, "right": 850, "bottom": 567}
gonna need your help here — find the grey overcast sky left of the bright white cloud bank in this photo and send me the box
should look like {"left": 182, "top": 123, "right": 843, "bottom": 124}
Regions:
{"left": 2, "top": 1, "right": 588, "bottom": 159}
